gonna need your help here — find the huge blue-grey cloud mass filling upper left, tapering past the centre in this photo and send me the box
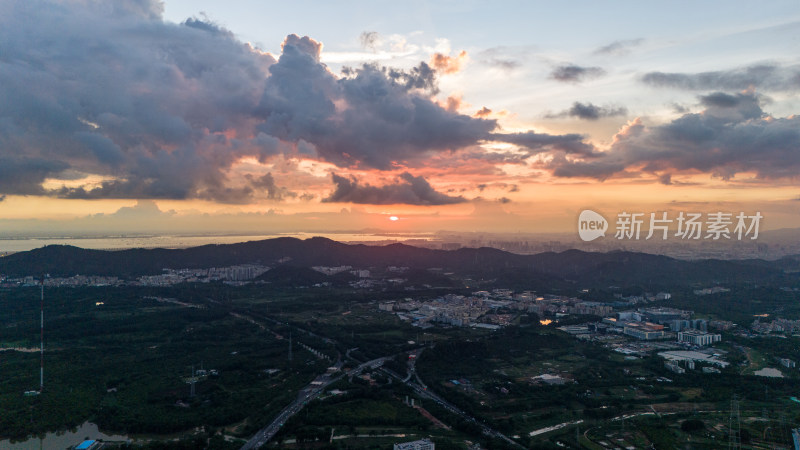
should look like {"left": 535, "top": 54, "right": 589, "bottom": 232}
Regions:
{"left": 0, "top": 0, "right": 506, "bottom": 203}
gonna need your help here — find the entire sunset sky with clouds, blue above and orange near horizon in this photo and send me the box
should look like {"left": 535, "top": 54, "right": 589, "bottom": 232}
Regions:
{"left": 0, "top": 0, "right": 800, "bottom": 234}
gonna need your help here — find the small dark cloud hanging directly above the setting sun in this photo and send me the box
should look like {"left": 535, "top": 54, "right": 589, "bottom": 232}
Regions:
{"left": 322, "top": 172, "right": 467, "bottom": 205}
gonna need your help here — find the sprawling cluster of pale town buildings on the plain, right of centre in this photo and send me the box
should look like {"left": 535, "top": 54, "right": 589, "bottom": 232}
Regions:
{"left": 378, "top": 289, "right": 744, "bottom": 378}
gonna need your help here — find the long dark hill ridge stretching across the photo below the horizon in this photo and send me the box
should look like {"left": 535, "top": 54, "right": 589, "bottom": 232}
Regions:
{"left": 0, "top": 237, "right": 797, "bottom": 284}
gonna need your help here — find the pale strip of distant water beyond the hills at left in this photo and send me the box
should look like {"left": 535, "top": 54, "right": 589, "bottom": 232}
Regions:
{"left": 0, "top": 233, "right": 433, "bottom": 256}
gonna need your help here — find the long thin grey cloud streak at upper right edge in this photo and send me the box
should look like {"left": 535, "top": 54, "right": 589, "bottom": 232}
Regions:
{"left": 642, "top": 64, "right": 800, "bottom": 91}
